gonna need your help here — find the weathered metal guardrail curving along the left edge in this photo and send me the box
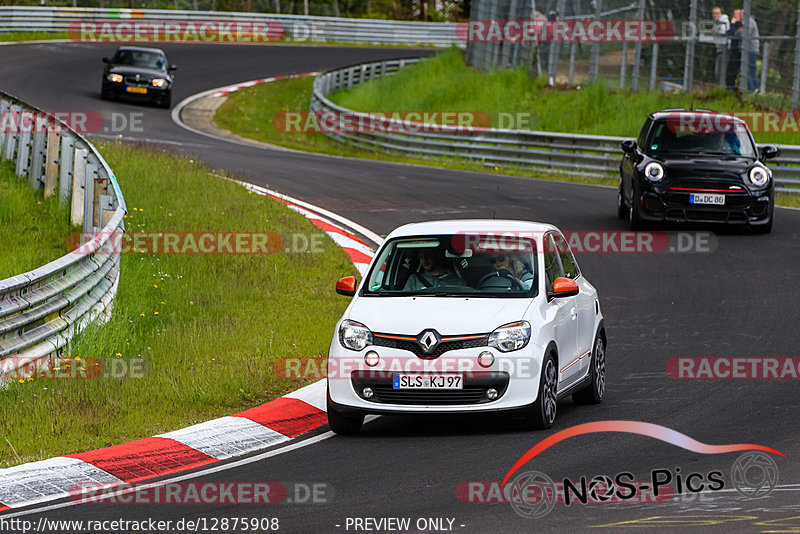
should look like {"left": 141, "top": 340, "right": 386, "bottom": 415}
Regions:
{"left": 0, "top": 92, "right": 126, "bottom": 375}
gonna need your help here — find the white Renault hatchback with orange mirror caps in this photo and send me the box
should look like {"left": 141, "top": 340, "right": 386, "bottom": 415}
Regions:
{"left": 327, "top": 220, "right": 606, "bottom": 434}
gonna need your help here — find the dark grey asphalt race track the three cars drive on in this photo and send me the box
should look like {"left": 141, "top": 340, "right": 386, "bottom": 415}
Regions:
{"left": 0, "top": 44, "right": 800, "bottom": 533}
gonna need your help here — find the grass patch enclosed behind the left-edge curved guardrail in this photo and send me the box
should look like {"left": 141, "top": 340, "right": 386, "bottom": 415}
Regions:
{"left": 0, "top": 162, "right": 77, "bottom": 280}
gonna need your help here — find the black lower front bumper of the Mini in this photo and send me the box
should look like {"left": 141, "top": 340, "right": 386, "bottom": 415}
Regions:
{"left": 639, "top": 184, "right": 774, "bottom": 226}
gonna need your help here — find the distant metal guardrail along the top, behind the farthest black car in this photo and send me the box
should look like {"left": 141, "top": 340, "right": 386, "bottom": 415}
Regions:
{"left": 0, "top": 7, "right": 466, "bottom": 47}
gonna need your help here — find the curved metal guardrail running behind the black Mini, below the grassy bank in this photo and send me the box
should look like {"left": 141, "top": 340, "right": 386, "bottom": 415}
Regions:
{"left": 310, "top": 58, "right": 800, "bottom": 192}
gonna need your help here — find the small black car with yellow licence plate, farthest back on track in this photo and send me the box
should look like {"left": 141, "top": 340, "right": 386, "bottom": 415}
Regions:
{"left": 100, "top": 46, "right": 178, "bottom": 108}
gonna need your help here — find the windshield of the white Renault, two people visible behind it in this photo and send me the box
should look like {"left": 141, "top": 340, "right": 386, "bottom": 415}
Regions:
{"left": 363, "top": 234, "right": 537, "bottom": 297}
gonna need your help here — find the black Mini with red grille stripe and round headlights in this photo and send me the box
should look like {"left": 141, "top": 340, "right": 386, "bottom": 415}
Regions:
{"left": 617, "top": 109, "right": 778, "bottom": 233}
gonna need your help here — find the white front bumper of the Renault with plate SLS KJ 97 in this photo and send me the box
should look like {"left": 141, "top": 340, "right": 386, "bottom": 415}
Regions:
{"left": 328, "top": 339, "right": 544, "bottom": 414}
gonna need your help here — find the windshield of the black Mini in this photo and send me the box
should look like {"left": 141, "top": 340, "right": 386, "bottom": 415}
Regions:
{"left": 645, "top": 120, "right": 756, "bottom": 158}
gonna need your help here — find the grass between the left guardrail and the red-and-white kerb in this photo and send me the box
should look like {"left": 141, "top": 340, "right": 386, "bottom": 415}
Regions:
{"left": 0, "top": 144, "right": 355, "bottom": 467}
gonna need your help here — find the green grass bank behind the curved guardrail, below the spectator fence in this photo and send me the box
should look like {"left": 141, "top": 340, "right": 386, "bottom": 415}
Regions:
{"left": 331, "top": 49, "right": 800, "bottom": 144}
